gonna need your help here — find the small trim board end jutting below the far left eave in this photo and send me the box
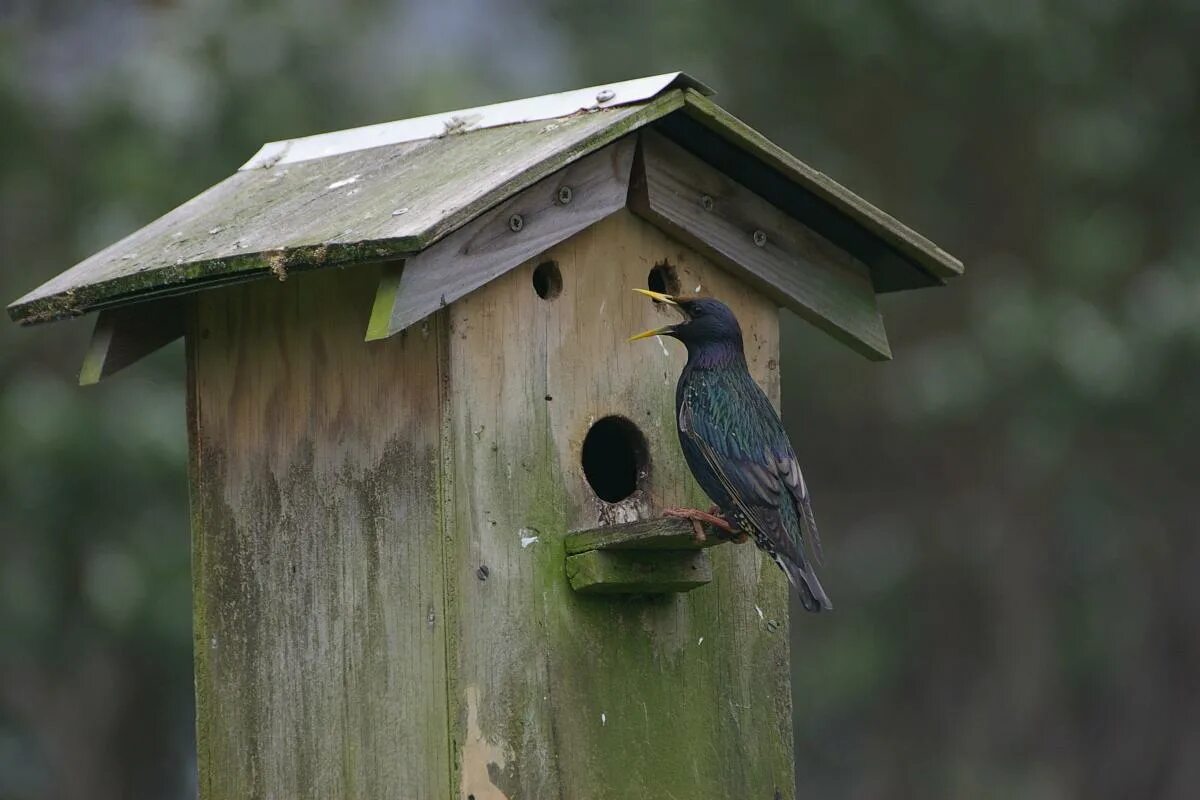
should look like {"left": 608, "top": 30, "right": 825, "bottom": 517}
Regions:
{"left": 79, "top": 299, "right": 187, "bottom": 386}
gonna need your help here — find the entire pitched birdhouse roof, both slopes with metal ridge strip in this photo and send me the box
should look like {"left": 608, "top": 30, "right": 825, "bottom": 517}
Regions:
{"left": 8, "top": 72, "right": 962, "bottom": 323}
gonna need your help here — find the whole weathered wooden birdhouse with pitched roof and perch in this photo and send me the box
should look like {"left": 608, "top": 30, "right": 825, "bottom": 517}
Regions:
{"left": 10, "top": 73, "right": 961, "bottom": 800}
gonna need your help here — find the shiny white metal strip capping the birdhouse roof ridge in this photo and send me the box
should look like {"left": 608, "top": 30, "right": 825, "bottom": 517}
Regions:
{"left": 239, "top": 72, "right": 714, "bottom": 172}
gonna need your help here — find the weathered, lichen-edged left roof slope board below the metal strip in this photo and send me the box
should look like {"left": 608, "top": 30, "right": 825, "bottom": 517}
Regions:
{"left": 8, "top": 94, "right": 683, "bottom": 323}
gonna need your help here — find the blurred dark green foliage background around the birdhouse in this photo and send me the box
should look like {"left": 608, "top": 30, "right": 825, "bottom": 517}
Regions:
{"left": 0, "top": 0, "right": 1200, "bottom": 800}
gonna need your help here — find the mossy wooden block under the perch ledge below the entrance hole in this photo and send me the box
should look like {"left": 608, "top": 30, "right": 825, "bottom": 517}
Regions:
{"left": 566, "top": 551, "right": 713, "bottom": 595}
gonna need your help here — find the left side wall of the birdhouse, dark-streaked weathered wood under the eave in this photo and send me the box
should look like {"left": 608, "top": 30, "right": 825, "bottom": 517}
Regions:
{"left": 188, "top": 266, "right": 451, "bottom": 800}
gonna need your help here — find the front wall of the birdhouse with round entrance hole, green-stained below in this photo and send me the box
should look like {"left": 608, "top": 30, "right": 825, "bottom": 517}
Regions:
{"left": 448, "top": 211, "right": 792, "bottom": 800}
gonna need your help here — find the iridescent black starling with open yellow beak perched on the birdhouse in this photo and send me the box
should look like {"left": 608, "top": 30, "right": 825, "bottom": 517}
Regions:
{"left": 630, "top": 289, "right": 833, "bottom": 612}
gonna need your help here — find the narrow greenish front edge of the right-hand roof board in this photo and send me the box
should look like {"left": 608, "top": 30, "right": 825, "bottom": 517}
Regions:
{"left": 684, "top": 90, "right": 962, "bottom": 278}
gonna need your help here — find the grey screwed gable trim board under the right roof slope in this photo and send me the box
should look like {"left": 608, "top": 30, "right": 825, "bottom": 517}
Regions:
{"left": 630, "top": 131, "right": 892, "bottom": 361}
